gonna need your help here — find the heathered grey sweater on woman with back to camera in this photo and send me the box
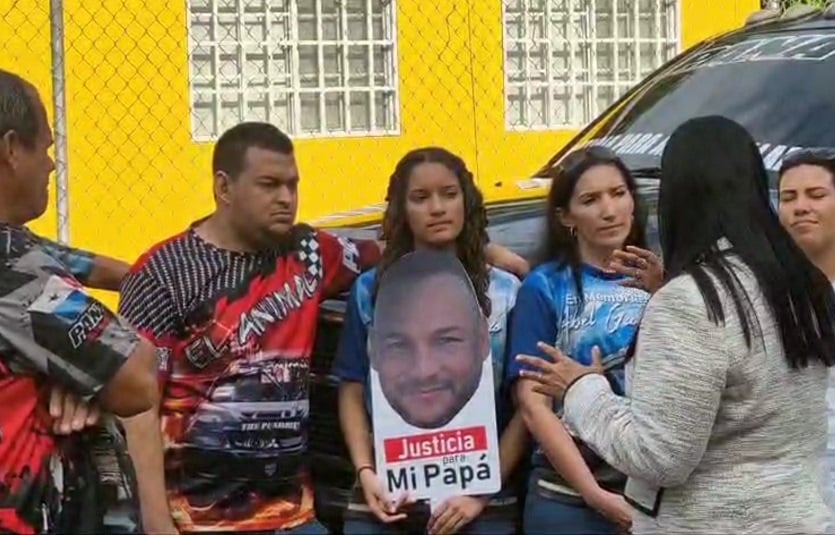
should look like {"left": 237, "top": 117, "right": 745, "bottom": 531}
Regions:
{"left": 565, "top": 258, "right": 830, "bottom": 535}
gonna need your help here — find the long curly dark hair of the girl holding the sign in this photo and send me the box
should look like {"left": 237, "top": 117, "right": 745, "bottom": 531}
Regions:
{"left": 374, "top": 147, "right": 490, "bottom": 316}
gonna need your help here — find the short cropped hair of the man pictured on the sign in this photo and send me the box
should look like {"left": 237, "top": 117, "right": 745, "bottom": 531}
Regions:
{"left": 374, "top": 249, "right": 482, "bottom": 326}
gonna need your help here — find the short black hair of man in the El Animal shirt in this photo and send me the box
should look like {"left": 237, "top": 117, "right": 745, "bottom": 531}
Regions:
{"left": 212, "top": 122, "right": 293, "bottom": 178}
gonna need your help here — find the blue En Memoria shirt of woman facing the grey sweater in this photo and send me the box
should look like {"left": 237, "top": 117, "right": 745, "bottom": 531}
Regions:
{"left": 508, "top": 262, "right": 649, "bottom": 496}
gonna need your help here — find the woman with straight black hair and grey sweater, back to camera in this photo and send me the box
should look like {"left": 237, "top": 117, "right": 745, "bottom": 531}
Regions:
{"left": 517, "top": 117, "right": 835, "bottom": 535}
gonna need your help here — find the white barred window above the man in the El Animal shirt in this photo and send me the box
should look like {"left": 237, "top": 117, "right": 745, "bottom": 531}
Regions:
{"left": 187, "top": 0, "right": 399, "bottom": 141}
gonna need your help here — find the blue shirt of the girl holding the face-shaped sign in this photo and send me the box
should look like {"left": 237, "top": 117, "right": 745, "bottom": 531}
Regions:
{"left": 333, "top": 267, "right": 521, "bottom": 503}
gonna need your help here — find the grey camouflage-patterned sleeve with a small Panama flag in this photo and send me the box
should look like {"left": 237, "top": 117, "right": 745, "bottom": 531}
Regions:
{"left": 0, "top": 245, "right": 139, "bottom": 399}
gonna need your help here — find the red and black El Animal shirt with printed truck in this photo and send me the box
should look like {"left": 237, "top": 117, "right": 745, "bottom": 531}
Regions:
{"left": 120, "top": 226, "right": 379, "bottom": 532}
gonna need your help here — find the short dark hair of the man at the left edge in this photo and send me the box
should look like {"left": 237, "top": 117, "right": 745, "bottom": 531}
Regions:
{"left": 0, "top": 69, "right": 38, "bottom": 149}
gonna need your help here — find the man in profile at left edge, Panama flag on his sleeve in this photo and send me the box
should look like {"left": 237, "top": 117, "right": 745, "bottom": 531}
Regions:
{"left": 0, "top": 70, "right": 158, "bottom": 533}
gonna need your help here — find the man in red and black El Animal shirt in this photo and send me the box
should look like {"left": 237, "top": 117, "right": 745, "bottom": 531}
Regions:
{"left": 120, "top": 123, "right": 380, "bottom": 533}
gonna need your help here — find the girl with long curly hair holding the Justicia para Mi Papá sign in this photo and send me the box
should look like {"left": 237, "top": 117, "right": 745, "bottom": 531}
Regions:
{"left": 334, "top": 147, "right": 527, "bottom": 534}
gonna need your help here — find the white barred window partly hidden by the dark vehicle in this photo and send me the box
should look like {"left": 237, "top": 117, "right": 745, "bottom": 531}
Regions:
{"left": 502, "top": 0, "right": 681, "bottom": 130}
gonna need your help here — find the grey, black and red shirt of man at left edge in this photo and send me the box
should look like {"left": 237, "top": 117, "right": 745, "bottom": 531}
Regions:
{"left": 0, "top": 225, "right": 139, "bottom": 533}
